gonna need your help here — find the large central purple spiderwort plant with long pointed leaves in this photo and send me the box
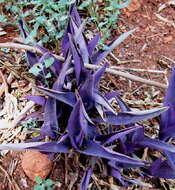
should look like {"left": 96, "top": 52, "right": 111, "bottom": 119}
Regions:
{"left": 0, "top": 4, "right": 175, "bottom": 190}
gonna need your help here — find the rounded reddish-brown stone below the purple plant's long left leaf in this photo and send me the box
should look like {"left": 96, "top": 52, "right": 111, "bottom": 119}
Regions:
{"left": 22, "top": 150, "right": 52, "bottom": 181}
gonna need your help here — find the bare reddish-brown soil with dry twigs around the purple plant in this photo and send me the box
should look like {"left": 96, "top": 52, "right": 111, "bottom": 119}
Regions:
{"left": 0, "top": 0, "right": 175, "bottom": 190}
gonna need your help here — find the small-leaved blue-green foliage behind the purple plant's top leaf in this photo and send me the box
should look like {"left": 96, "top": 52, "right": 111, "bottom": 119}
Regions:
{"left": 0, "top": 0, "right": 131, "bottom": 44}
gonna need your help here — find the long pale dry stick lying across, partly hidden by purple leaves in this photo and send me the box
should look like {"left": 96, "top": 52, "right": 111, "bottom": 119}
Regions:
{"left": 0, "top": 42, "right": 167, "bottom": 89}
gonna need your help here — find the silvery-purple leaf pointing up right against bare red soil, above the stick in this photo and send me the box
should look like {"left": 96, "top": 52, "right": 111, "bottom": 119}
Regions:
{"left": 92, "top": 29, "right": 135, "bottom": 64}
